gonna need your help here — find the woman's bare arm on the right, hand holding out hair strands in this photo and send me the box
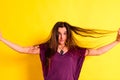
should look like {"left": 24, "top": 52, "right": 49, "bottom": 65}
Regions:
{"left": 85, "top": 29, "right": 120, "bottom": 56}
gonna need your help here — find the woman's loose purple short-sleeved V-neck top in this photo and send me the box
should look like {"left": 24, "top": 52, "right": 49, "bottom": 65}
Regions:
{"left": 40, "top": 44, "right": 86, "bottom": 80}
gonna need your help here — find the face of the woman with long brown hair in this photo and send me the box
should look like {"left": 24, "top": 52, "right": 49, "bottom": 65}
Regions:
{"left": 58, "top": 27, "right": 67, "bottom": 45}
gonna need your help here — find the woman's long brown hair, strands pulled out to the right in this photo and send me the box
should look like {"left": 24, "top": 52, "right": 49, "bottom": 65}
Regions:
{"left": 45, "top": 22, "right": 114, "bottom": 69}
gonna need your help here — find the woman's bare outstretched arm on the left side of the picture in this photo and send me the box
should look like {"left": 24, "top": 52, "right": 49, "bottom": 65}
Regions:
{"left": 0, "top": 33, "right": 40, "bottom": 54}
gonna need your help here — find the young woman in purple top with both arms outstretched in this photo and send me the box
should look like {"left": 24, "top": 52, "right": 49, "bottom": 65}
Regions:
{"left": 0, "top": 22, "right": 120, "bottom": 80}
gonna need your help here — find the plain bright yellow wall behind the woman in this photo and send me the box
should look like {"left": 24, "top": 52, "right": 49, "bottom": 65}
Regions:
{"left": 0, "top": 0, "right": 120, "bottom": 80}
